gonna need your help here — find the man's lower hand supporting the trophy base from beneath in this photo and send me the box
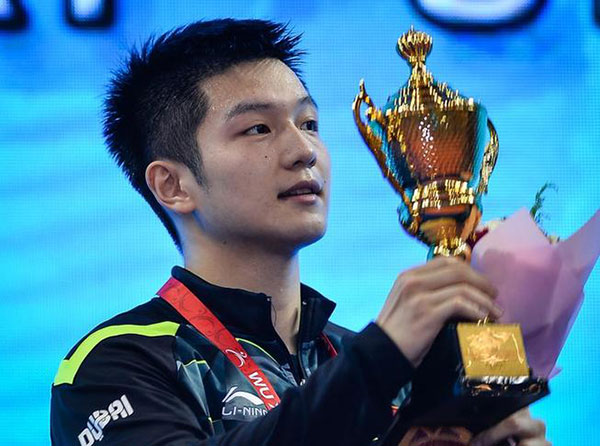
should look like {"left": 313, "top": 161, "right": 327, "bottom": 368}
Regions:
{"left": 471, "top": 408, "right": 551, "bottom": 446}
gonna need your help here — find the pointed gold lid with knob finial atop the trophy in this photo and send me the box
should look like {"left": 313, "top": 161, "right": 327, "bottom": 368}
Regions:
{"left": 396, "top": 27, "right": 477, "bottom": 114}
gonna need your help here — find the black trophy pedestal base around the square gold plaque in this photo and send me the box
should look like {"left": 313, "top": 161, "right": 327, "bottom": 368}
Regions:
{"left": 383, "top": 323, "right": 549, "bottom": 446}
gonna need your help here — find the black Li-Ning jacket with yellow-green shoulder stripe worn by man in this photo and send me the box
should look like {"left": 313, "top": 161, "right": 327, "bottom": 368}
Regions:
{"left": 51, "top": 267, "right": 412, "bottom": 446}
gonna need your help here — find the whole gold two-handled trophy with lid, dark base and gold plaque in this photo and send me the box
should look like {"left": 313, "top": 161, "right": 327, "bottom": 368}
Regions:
{"left": 352, "top": 28, "right": 548, "bottom": 446}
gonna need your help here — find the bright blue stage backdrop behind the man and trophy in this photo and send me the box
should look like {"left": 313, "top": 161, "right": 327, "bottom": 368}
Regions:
{"left": 0, "top": 0, "right": 600, "bottom": 446}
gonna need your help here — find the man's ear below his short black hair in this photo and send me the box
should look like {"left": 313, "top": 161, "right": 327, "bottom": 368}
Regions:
{"left": 146, "top": 160, "right": 196, "bottom": 214}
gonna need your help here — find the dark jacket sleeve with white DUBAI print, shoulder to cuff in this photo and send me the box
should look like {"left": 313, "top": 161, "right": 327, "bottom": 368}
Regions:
{"left": 51, "top": 324, "right": 413, "bottom": 446}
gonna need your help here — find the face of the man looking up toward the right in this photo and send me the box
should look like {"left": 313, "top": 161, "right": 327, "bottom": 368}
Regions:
{"left": 194, "top": 59, "right": 330, "bottom": 252}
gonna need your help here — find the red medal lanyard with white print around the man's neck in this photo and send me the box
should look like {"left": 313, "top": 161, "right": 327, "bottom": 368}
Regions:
{"left": 156, "top": 277, "right": 337, "bottom": 410}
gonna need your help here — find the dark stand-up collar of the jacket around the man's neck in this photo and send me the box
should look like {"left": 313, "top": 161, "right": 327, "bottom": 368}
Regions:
{"left": 171, "top": 266, "right": 335, "bottom": 342}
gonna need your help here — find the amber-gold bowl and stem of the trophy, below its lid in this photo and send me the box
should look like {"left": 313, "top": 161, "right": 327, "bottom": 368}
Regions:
{"left": 388, "top": 105, "right": 493, "bottom": 258}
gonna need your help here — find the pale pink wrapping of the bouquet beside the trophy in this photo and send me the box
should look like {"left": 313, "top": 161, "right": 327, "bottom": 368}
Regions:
{"left": 471, "top": 209, "right": 600, "bottom": 377}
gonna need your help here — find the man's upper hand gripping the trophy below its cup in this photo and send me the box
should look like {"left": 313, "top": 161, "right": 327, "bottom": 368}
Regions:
{"left": 375, "top": 257, "right": 502, "bottom": 367}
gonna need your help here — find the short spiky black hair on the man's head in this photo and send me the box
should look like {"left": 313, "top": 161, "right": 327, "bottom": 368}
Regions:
{"left": 104, "top": 19, "right": 304, "bottom": 251}
